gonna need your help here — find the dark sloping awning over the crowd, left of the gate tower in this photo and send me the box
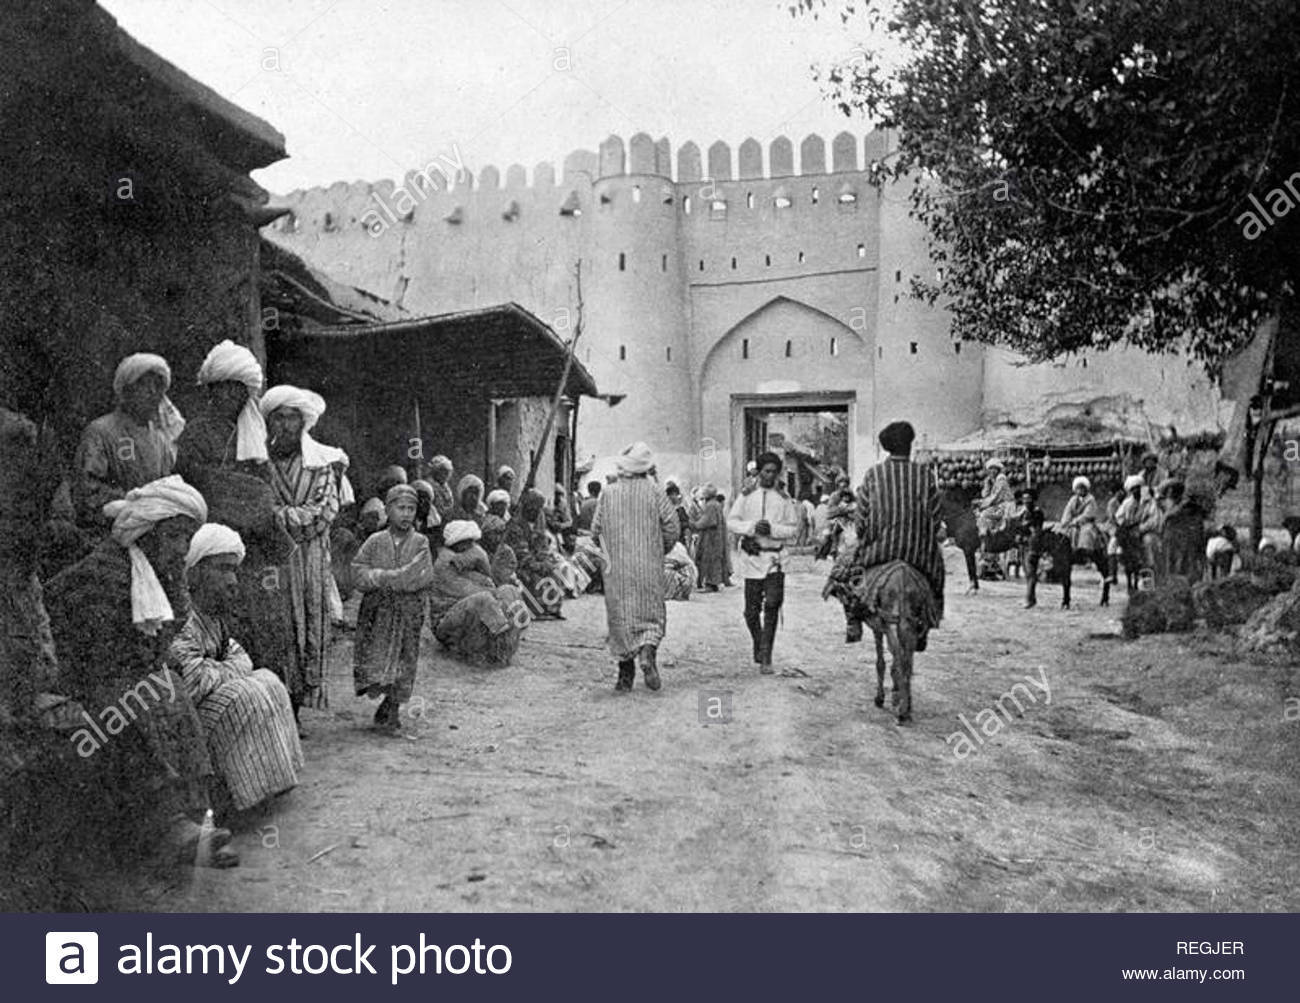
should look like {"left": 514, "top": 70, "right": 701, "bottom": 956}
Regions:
{"left": 267, "top": 303, "right": 597, "bottom": 399}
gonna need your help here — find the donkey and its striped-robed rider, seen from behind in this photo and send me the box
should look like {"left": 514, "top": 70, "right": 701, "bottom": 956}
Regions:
{"left": 822, "top": 421, "right": 944, "bottom": 721}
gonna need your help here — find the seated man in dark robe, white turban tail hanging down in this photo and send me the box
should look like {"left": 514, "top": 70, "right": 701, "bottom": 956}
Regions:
{"left": 46, "top": 476, "right": 239, "bottom": 867}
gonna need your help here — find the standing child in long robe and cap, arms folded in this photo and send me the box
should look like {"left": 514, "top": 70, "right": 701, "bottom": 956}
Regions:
{"left": 352, "top": 485, "right": 433, "bottom": 734}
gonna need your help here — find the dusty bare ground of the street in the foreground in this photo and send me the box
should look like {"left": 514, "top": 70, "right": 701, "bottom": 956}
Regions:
{"left": 149, "top": 555, "right": 1300, "bottom": 912}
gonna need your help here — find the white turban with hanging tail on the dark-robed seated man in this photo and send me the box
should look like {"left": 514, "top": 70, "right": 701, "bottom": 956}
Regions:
{"left": 104, "top": 474, "right": 208, "bottom": 637}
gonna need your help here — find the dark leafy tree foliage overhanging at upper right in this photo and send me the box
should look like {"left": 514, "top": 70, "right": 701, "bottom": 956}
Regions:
{"left": 790, "top": 0, "right": 1300, "bottom": 370}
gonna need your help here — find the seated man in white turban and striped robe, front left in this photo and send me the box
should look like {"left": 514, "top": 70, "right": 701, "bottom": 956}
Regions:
{"left": 169, "top": 522, "right": 303, "bottom": 811}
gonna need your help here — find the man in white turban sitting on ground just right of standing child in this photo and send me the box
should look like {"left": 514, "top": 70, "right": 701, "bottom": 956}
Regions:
{"left": 429, "top": 520, "right": 530, "bottom": 665}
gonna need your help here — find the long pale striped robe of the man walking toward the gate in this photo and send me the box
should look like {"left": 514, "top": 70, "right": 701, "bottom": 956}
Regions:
{"left": 592, "top": 477, "right": 679, "bottom": 661}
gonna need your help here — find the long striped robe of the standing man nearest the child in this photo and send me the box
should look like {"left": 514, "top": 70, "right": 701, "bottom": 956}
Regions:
{"left": 270, "top": 453, "right": 339, "bottom": 707}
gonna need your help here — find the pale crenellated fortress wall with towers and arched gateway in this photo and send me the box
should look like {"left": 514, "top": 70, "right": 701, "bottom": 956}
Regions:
{"left": 256, "top": 130, "right": 1217, "bottom": 482}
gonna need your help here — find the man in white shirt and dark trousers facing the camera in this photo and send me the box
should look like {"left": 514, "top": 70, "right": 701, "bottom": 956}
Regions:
{"left": 727, "top": 452, "right": 798, "bottom": 676}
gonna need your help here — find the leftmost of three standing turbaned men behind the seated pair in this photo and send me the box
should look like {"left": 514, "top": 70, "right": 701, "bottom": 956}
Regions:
{"left": 72, "top": 352, "right": 185, "bottom": 537}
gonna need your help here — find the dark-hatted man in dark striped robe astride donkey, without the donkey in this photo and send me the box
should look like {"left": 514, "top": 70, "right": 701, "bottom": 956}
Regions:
{"left": 824, "top": 421, "right": 944, "bottom": 651}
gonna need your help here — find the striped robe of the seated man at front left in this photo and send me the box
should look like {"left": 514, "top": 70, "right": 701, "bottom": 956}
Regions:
{"left": 168, "top": 611, "right": 303, "bottom": 811}
